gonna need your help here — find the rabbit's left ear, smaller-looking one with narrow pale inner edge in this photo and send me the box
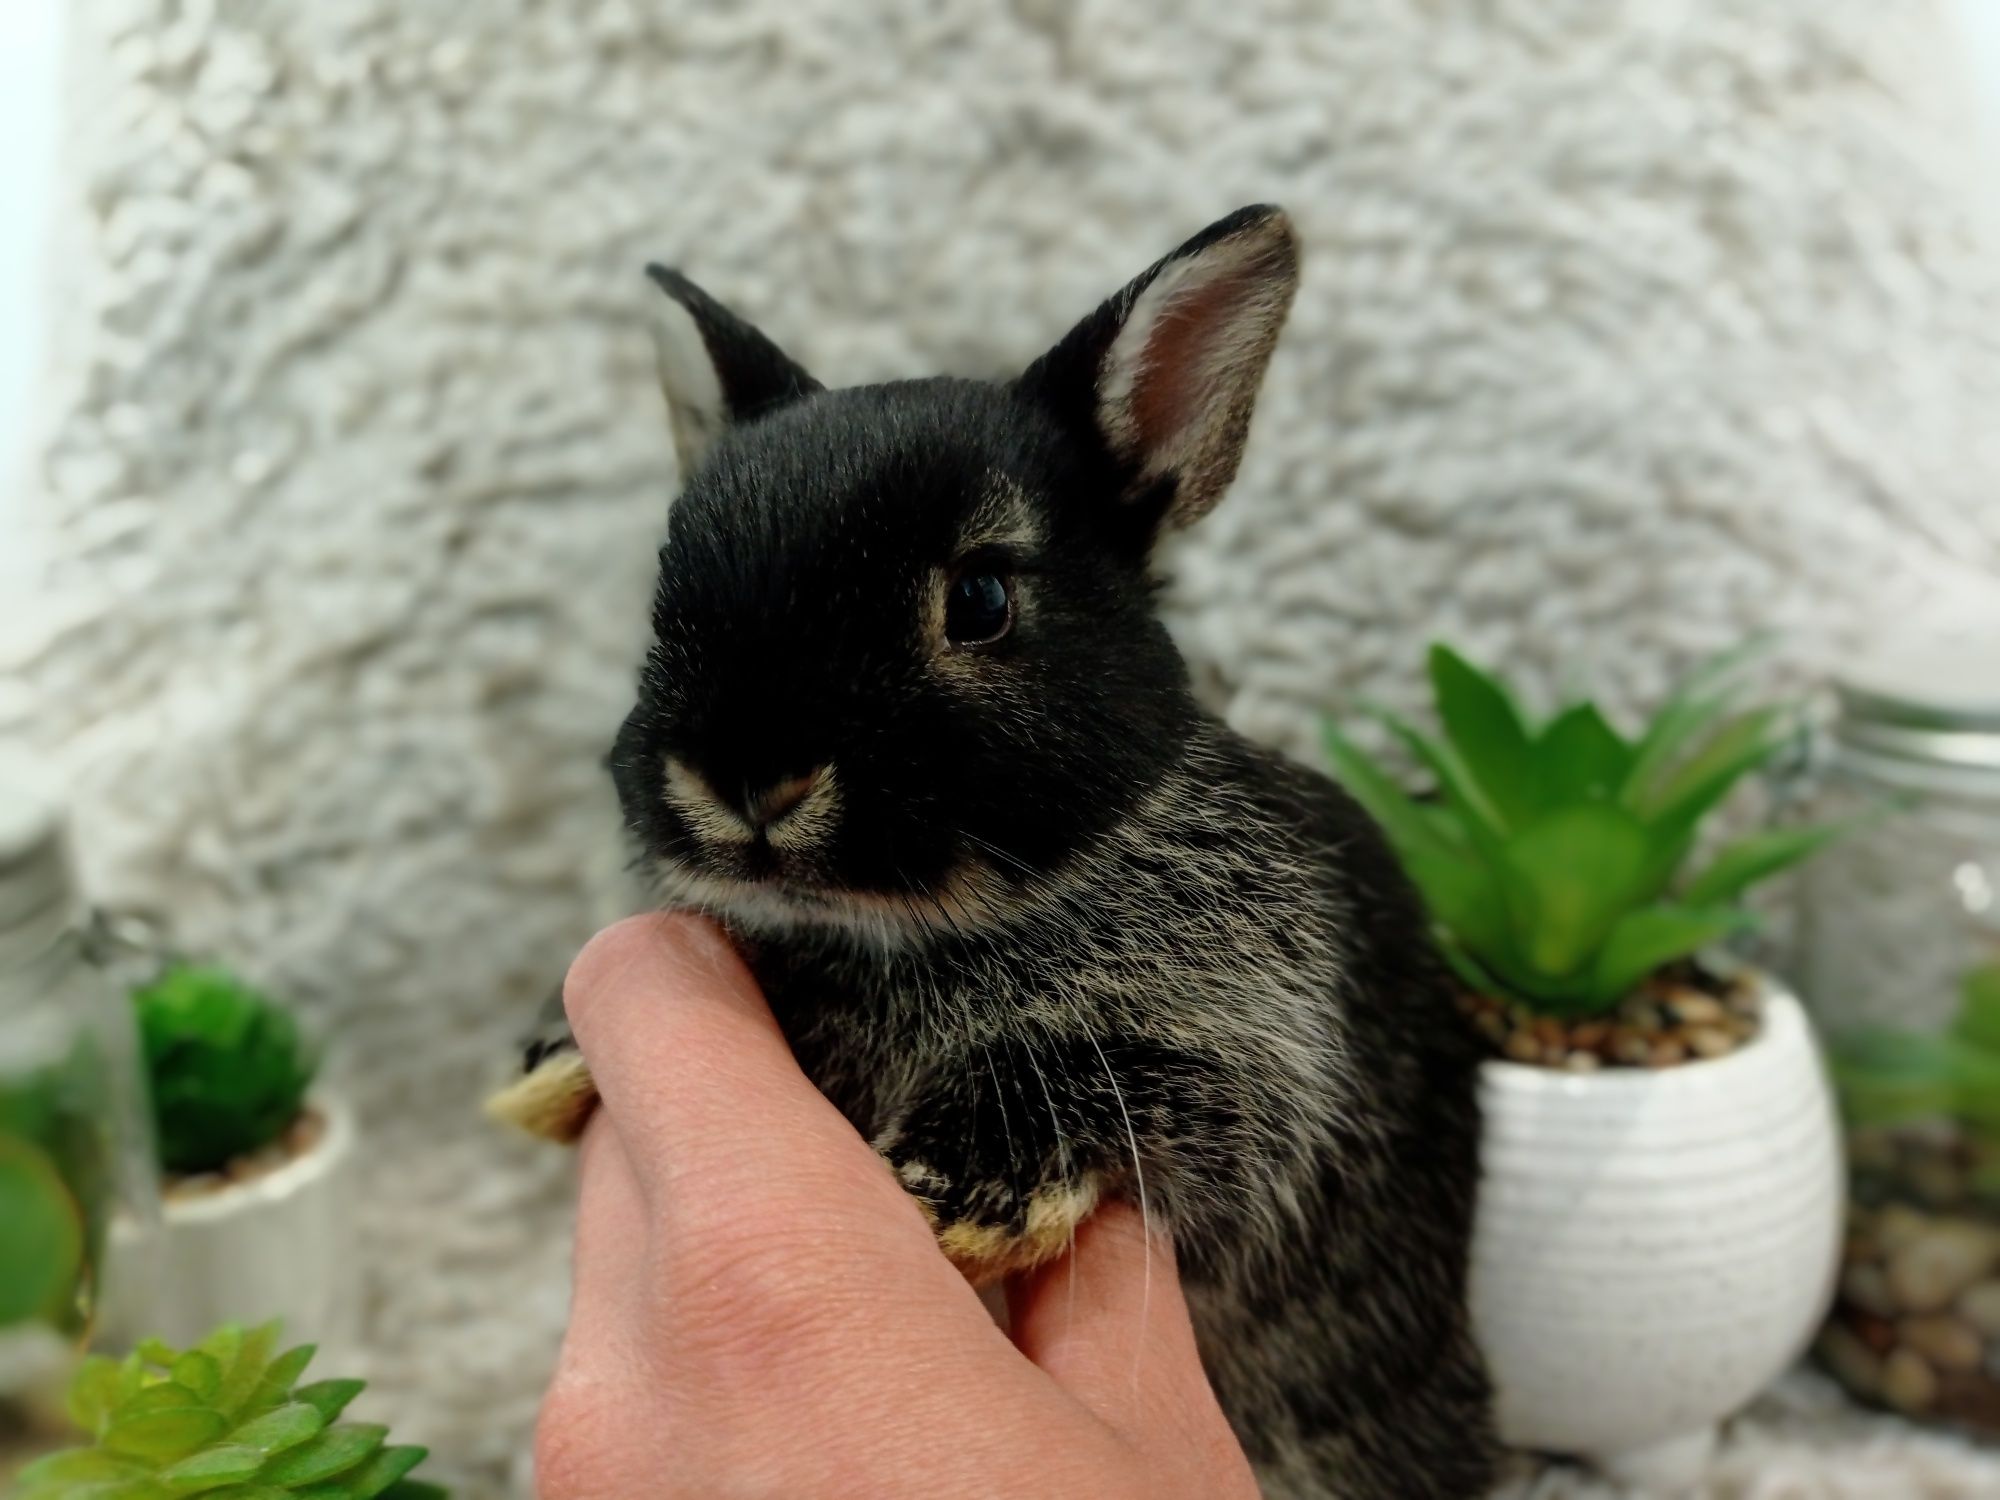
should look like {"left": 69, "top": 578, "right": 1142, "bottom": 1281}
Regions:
{"left": 646, "top": 266, "right": 820, "bottom": 474}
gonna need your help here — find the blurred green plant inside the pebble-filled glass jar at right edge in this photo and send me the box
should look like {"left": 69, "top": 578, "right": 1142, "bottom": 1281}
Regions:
{"left": 1828, "top": 962, "right": 2000, "bottom": 1144}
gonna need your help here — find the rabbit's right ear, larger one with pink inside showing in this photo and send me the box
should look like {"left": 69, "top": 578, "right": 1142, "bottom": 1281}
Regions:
{"left": 1020, "top": 204, "right": 1298, "bottom": 526}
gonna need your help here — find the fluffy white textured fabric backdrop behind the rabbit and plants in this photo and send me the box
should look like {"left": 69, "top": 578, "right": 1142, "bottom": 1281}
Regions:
{"left": 11, "top": 0, "right": 2000, "bottom": 1500}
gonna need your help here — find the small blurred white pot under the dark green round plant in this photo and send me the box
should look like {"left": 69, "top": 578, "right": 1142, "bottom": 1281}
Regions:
{"left": 104, "top": 1098, "right": 360, "bottom": 1350}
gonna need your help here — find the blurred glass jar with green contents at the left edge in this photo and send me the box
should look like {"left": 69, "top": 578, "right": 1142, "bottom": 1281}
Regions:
{"left": 0, "top": 764, "right": 158, "bottom": 1452}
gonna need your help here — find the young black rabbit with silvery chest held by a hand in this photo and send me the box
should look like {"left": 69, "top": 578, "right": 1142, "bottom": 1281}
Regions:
{"left": 496, "top": 206, "right": 1494, "bottom": 1500}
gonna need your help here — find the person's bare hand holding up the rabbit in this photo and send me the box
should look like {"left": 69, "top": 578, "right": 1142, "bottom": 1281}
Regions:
{"left": 536, "top": 916, "right": 1258, "bottom": 1500}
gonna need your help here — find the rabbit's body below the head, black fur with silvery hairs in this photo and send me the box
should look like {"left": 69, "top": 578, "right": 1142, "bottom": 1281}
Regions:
{"left": 754, "top": 726, "right": 1486, "bottom": 1496}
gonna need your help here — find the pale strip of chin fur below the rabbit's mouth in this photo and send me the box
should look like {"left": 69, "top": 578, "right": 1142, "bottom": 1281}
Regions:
{"left": 644, "top": 860, "right": 1020, "bottom": 952}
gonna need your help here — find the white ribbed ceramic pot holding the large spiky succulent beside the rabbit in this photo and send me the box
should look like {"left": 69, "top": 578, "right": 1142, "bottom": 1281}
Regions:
{"left": 1472, "top": 984, "right": 1844, "bottom": 1492}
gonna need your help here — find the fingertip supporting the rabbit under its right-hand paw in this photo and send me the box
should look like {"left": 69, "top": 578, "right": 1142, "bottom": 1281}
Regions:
{"left": 1008, "top": 1202, "right": 1234, "bottom": 1450}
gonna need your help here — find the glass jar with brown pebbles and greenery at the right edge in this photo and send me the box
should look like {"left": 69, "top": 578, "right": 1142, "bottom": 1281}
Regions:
{"left": 1796, "top": 644, "right": 2000, "bottom": 1436}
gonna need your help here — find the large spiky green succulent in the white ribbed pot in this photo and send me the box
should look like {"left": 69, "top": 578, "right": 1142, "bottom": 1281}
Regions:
{"left": 1326, "top": 644, "right": 1840, "bottom": 1016}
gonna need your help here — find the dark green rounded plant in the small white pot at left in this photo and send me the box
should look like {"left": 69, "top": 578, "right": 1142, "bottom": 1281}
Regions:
{"left": 132, "top": 964, "right": 318, "bottom": 1172}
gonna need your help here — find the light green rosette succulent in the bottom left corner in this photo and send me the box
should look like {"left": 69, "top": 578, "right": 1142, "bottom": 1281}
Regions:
{"left": 16, "top": 1324, "right": 444, "bottom": 1500}
